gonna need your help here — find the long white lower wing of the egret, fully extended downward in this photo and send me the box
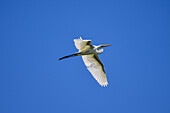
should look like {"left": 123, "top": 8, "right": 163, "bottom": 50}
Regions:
{"left": 82, "top": 54, "right": 108, "bottom": 86}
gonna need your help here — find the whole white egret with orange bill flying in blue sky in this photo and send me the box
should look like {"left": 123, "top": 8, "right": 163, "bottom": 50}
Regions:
{"left": 59, "top": 37, "right": 111, "bottom": 87}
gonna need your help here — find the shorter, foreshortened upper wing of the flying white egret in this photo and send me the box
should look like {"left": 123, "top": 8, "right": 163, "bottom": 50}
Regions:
{"left": 74, "top": 37, "right": 93, "bottom": 51}
